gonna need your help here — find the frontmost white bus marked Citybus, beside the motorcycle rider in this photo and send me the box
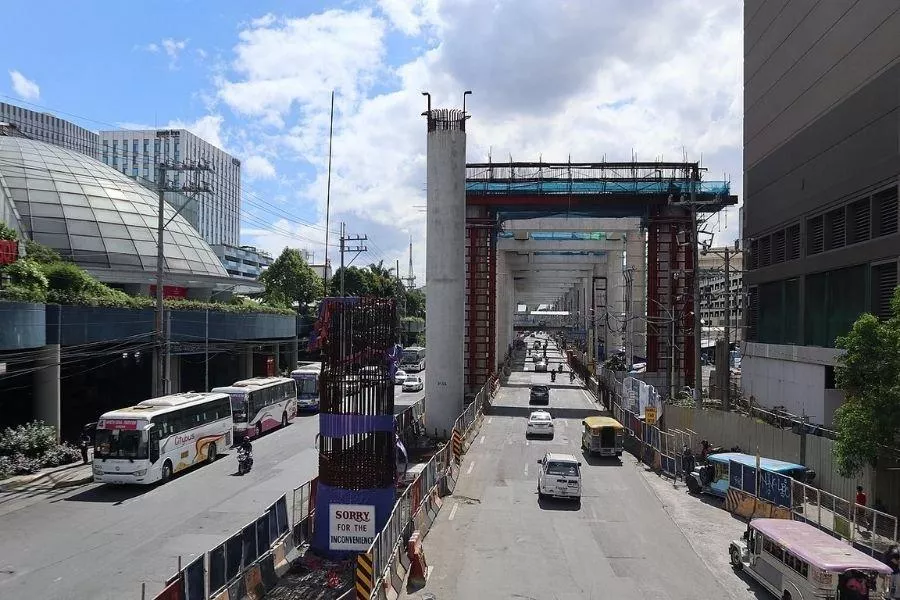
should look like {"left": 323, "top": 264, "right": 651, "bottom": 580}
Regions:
{"left": 93, "top": 392, "right": 234, "bottom": 484}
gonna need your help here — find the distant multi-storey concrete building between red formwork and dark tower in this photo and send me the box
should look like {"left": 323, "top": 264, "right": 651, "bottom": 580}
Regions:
{"left": 700, "top": 248, "right": 744, "bottom": 348}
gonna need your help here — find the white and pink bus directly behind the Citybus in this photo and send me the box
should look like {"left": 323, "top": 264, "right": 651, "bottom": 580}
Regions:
{"left": 213, "top": 377, "right": 297, "bottom": 439}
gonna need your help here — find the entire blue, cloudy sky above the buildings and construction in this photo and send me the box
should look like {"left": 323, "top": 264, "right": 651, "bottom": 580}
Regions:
{"left": 0, "top": 0, "right": 743, "bottom": 285}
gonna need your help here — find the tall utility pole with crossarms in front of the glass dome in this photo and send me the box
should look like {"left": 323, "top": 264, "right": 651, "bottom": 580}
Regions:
{"left": 155, "top": 157, "right": 212, "bottom": 396}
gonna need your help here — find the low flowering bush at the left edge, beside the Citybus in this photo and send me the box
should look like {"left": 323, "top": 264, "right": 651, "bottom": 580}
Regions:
{"left": 0, "top": 421, "right": 81, "bottom": 479}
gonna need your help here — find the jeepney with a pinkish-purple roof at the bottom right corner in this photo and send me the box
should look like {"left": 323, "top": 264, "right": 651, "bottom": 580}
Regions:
{"left": 728, "top": 519, "right": 891, "bottom": 600}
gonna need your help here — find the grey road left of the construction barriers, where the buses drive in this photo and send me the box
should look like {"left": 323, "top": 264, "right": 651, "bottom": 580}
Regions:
{"left": 0, "top": 373, "right": 424, "bottom": 600}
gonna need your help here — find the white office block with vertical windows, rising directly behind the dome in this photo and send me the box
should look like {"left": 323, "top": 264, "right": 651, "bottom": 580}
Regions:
{"left": 100, "top": 129, "right": 241, "bottom": 246}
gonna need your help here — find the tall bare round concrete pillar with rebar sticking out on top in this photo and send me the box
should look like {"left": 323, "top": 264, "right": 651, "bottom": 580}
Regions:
{"left": 425, "top": 110, "right": 466, "bottom": 435}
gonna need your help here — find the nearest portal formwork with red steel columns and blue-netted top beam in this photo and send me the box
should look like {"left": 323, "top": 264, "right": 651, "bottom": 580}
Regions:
{"left": 465, "top": 162, "right": 737, "bottom": 392}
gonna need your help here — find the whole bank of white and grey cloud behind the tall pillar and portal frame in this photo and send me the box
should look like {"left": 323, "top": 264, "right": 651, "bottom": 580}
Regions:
{"left": 218, "top": 0, "right": 743, "bottom": 271}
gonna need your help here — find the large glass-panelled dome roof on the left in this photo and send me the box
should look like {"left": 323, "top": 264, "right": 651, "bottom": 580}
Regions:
{"left": 0, "top": 135, "right": 246, "bottom": 298}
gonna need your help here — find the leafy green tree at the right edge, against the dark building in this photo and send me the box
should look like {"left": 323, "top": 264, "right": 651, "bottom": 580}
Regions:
{"left": 834, "top": 287, "right": 900, "bottom": 477}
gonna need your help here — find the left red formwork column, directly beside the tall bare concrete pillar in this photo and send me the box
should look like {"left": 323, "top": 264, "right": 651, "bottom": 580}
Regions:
{"left": 465, "top": 217, "right": 497, "bottom": 393}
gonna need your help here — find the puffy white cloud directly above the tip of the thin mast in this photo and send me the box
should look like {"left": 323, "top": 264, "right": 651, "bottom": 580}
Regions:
{"left": 219, "top": 10, "right": 385, "bottom": 125}
